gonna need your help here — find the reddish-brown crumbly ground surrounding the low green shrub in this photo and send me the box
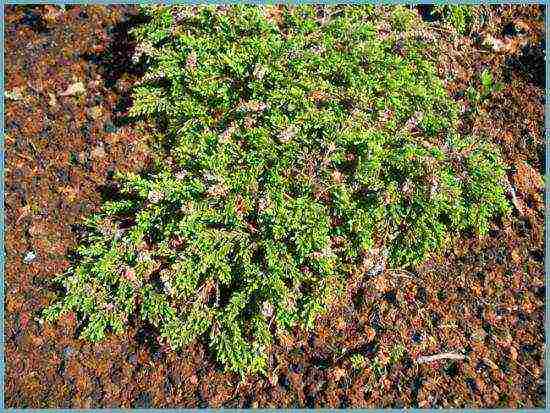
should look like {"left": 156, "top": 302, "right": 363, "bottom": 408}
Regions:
{"left": 4, "top": 6, "right": 545, "bottom": 408}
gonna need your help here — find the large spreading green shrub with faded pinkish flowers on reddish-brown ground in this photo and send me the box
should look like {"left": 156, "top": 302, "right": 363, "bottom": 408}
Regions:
{"left": 46, "top": 6, "right": 508, "bottom": 375}
